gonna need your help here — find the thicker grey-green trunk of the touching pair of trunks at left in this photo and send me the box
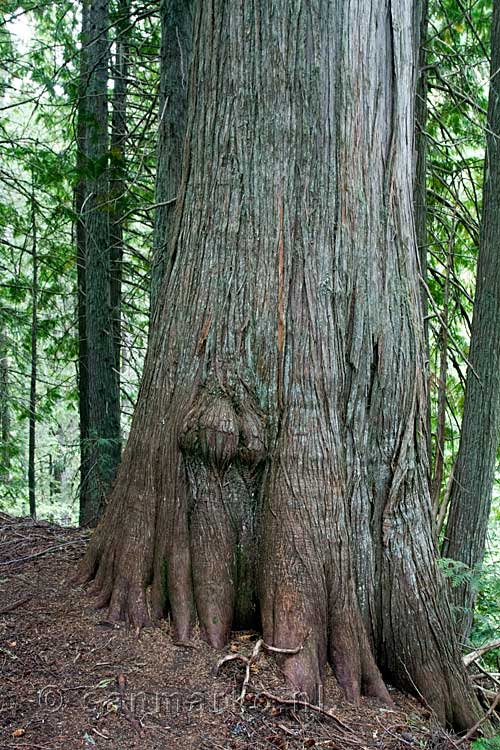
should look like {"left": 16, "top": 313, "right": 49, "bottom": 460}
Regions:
{"left": 80, "top": 0, "right": 120, "bottom": 525}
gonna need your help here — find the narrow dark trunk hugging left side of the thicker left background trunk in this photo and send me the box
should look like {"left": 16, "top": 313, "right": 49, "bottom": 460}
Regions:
{"left": 74, "top": 0, "right": 91, "bottom": 526}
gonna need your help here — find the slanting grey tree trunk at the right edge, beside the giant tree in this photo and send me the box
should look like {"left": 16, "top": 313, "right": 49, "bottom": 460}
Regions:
{"left": 442, "top": 0, "right": 500, "bottom": 638}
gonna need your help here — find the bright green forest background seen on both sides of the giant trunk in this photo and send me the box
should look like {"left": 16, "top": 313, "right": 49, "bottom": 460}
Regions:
{"left": 0, "top": 0, "right": 500, "bottom": 656}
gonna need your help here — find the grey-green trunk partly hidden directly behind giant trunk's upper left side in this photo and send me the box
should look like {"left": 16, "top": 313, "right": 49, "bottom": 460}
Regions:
{"left": 151, "top": 0, "right": 195, "bottom": 316}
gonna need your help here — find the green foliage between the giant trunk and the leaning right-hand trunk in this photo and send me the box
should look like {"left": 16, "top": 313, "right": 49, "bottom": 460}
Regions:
{"left": 426, "top": 0, "right": 491, "bottom": 500}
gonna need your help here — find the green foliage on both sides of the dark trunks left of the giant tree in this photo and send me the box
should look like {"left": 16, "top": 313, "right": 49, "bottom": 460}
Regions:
{"left": 0, "top": 0, "right": 160, "bottom": 522}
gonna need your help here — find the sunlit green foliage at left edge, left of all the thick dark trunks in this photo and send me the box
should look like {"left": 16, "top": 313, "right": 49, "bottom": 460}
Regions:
{"left": 0, "top": 2, "right": 82, "bottom": 517}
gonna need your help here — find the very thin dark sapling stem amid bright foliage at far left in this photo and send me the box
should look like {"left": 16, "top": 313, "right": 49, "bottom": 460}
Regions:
{"left": 28, "top": 180, "right": 38, "bottom": 518}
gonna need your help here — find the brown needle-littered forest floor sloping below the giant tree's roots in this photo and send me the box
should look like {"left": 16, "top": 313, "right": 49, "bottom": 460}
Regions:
{"left": 0, "top": 514, "right": 478, "bottom": 750}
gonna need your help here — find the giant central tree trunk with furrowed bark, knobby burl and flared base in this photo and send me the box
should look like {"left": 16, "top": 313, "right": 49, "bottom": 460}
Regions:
{"left": 80, "top": 0, "right": 476, "bottom": 727}
